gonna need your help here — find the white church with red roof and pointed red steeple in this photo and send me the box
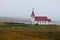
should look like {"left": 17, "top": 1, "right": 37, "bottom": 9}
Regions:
{"left": 31, "top": 9, "right": 51, "bottom": 25}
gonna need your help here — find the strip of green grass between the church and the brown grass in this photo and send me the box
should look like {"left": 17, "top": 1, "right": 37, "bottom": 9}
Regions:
{"left": 0, "top": 25, "right": 60, "bottom": 31}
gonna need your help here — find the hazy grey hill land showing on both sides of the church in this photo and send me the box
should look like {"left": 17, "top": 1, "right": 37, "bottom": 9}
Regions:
{"left": 0, "top": 17, "right": 60, "bottom": 25}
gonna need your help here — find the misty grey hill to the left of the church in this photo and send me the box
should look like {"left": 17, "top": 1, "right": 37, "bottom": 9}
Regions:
{"left": 0, "top": 17, "right": 30, "bottom": 23}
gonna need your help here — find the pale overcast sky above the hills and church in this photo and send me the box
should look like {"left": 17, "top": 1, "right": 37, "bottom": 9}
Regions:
{"left": 0, "top": 0, "right": 60, "bottom": 20}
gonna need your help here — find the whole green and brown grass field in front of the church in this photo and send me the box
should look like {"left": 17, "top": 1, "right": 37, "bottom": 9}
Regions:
{"left": 0, "top": 25, "right": 60, "bottom": 40}
